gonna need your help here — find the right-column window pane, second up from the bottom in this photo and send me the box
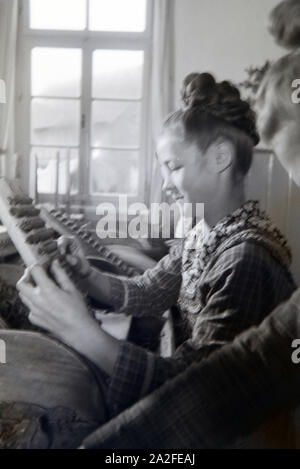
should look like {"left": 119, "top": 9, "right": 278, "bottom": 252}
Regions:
{"left": 92, "top": 101, "right": 141, "bottom": 148}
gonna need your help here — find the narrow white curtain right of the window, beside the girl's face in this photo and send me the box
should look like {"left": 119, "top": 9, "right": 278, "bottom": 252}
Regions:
{"left": 147, "top": 0, "right": 175, "bottom": 202}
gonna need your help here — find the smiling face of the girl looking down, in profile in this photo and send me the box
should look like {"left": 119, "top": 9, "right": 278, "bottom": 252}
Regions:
{"left": 157, "top": 130, "right": 223, "bottom": 203}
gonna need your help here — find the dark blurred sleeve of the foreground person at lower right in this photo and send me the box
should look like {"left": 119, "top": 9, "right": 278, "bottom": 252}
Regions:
{"left": 83, "top": 289, "right": 300, "bottom": 449}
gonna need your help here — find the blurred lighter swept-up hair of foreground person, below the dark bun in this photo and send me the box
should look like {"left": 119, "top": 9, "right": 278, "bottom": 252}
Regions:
{"left": 256, "top": 49, "right": 300, "bottom": 141}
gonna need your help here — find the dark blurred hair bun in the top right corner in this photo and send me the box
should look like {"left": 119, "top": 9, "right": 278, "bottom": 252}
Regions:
{"left": 269, "top": 0, "right": 300, "bottom": 49}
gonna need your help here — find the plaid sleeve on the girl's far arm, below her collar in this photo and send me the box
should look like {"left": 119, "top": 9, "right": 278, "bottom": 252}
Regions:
{"left": 110, "top": 240, "right": 183, "bottom": 316}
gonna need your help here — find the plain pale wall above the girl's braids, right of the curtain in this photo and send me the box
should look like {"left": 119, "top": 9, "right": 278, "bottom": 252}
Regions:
{"left": 175, "top": 0, "right": 284, "bottom": 101}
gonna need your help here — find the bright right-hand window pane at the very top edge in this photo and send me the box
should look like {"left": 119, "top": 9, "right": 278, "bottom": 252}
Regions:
{"left": 89, "top": 0, "right": 147, "bottom": 32}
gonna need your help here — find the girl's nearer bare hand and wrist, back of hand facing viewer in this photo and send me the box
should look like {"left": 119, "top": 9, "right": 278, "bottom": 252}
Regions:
{"left": 17, "top": 261, "right": 120, "bottom": 374}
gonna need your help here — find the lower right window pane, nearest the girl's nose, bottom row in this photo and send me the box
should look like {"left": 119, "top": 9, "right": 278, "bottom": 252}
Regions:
{"left": 90, "top": 150, "right": 139, "bottom": 195}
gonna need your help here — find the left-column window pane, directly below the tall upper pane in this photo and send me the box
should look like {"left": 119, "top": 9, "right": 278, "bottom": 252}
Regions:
{"left": 31, "top": 99, "right": 80, "bottom": 146}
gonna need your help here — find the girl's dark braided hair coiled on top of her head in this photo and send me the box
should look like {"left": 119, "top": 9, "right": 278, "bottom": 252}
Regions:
{"left": 181, "top": 73, "right": 259, "bottom": 145}
